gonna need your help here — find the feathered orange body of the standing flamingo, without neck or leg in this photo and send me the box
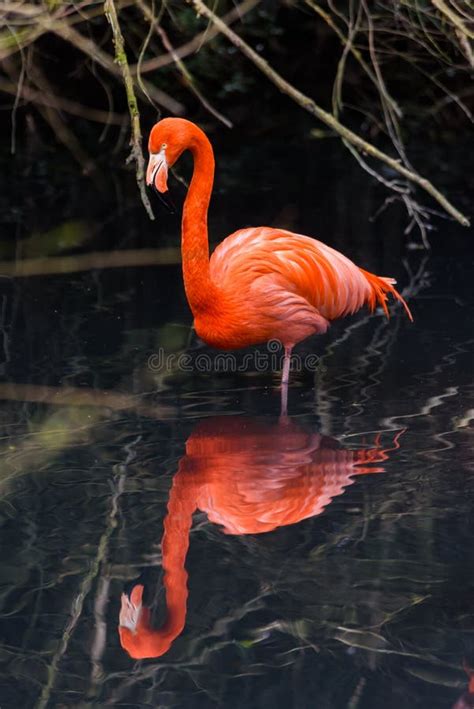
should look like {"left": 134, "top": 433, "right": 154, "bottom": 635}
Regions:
{"left": 204, "top": 227, "right": 400, "bottom": 349}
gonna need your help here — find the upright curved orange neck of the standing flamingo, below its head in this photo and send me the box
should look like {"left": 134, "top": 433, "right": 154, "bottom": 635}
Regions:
{"left": 181, "top": 126, "right": 215, "bottom": 315}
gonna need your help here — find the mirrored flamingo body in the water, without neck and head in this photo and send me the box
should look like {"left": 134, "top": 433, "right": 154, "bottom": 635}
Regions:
{"left": 173, "top": 416, "right": 388, "bottom": 535}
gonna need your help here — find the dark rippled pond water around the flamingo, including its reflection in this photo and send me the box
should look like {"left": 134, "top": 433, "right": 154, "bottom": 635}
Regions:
{"left": 0, "top": 134, "right": 474, "bottom": 709}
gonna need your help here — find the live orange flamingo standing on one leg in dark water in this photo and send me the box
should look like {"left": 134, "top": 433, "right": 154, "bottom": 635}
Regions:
{"left": 146, "top": 118, "right": 413, "bottom": 413}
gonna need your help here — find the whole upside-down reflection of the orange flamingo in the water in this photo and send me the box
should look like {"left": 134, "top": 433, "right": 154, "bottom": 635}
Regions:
{"left": 119, "top": 417, "right": 400, "bottom": 659}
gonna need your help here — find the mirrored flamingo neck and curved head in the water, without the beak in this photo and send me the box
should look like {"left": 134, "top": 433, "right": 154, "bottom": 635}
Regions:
{"left": 119, "top": 474, "right": 196, "bottom": 659}
